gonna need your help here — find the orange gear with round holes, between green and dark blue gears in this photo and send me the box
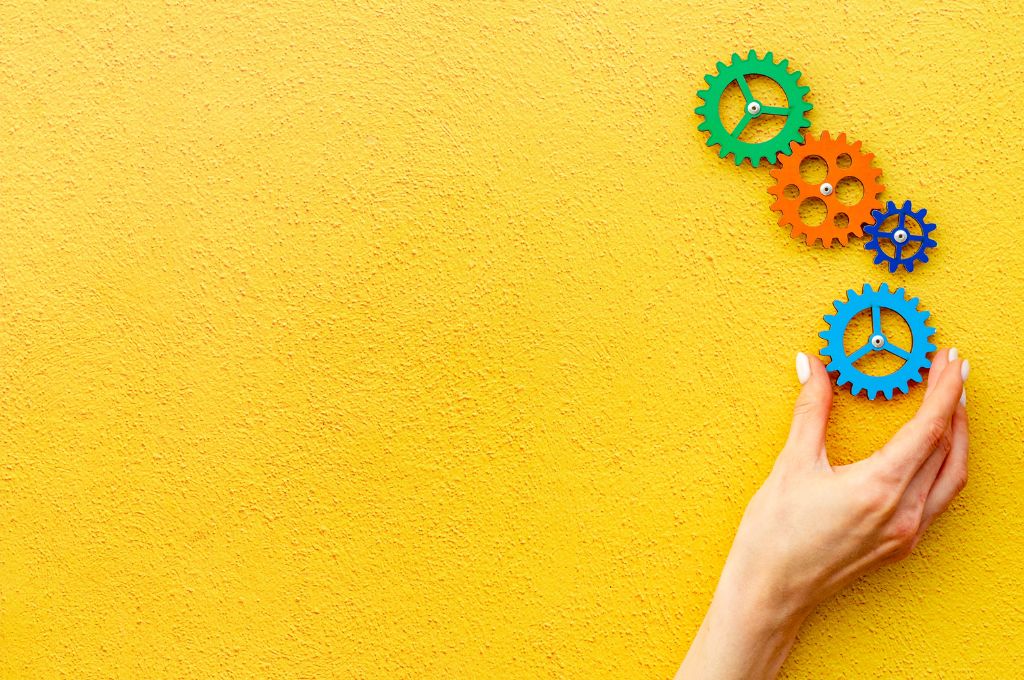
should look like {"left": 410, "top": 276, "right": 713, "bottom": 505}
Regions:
{"left": 768, "top": 132, "right": 885, "bottom": 248}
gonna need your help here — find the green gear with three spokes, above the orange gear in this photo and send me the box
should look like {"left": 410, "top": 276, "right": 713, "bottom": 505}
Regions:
{"left": 696, "top": 49, "right": 811, "bottom": 168}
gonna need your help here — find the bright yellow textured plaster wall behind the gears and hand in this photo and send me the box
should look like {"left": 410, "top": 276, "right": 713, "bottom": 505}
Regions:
{"left": 0, "top": 0, "right": 1024, "bottom": 678}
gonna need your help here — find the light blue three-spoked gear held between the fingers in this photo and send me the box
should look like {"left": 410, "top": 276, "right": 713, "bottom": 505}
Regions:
{"left": 818, "top": 284, "right": 936, "bottom": 399}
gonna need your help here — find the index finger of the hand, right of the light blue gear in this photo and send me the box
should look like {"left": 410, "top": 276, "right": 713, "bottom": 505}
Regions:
{"left": 877, "top": 359, "right": 964, "bottom": 482}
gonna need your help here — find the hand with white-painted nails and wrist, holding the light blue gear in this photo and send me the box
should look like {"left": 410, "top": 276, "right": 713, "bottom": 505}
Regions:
{"left": 677, "top": 349, "right": 969, "bottom": 680}
